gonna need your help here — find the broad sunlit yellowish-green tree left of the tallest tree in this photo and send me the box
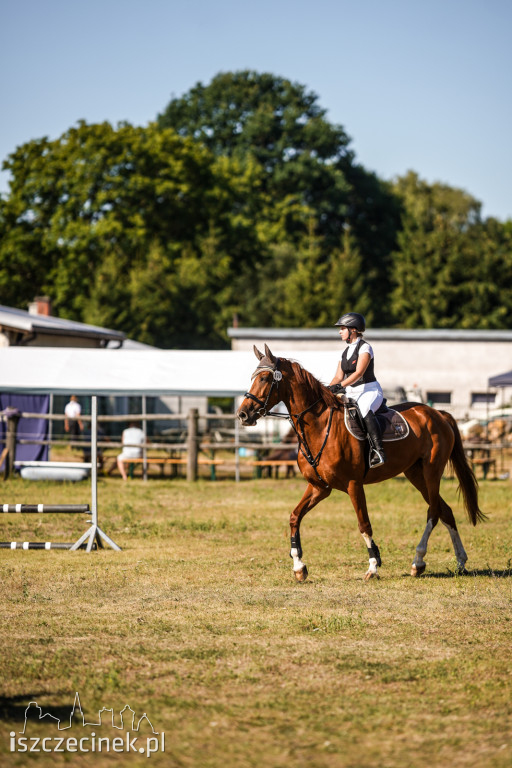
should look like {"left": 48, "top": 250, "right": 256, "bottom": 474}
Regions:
{"left": 0, "top": 123, "right": 217, "bottom": 319}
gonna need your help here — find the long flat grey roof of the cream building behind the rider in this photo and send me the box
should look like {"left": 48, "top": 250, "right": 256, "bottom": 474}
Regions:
{"left": 227, "top": 327, "right": 512, "bottom": 341}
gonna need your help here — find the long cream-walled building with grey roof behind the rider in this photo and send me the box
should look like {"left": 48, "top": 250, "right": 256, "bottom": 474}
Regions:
{"left": 228, "top": 327, "right": 512, "bottom": 419}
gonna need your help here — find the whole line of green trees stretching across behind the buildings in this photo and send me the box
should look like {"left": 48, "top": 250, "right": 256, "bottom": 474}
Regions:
{"left": 0, "top": 71, "right": 512, "bottom": 348}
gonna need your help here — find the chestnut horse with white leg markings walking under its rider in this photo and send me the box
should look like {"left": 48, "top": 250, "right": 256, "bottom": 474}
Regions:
{"left": 237, "top": 344, "right": 485, "bottom": 581}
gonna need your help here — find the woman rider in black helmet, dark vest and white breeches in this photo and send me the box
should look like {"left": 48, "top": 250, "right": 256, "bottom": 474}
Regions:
{"left": 329, "top": 312, "right": 386, "bottom": 467}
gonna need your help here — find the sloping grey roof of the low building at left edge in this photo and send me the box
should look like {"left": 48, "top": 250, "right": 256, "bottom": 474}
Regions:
{"left": 0, "top": 305, "right": 125, "bottom": 344}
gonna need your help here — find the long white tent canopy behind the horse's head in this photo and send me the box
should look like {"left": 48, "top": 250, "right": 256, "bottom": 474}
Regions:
{"left": 0, "top": 345, "right": 337, "bottom": 397}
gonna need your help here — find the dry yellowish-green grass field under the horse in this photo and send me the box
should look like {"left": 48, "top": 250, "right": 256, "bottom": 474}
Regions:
{"left": 0, "top": 479, "right": 512, "bottom": 768}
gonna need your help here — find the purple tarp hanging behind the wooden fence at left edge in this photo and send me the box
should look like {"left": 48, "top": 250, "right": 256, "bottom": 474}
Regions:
{"left": 0, "top": 393, "right": 50, "bottom": 469}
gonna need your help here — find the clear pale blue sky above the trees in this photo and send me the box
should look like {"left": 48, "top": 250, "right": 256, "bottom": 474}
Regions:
{"left": 0, "top": 0, "right": 512, "bottom": 220}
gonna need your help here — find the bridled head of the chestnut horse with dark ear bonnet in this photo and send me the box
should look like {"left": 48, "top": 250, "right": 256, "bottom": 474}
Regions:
{"left": 237, "top": 344, "right": 283, "bottom": 427}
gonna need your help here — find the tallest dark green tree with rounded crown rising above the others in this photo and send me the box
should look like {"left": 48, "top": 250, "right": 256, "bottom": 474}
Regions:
{"left": 157, "top": 70, "right": 399, "bottom": 324}
